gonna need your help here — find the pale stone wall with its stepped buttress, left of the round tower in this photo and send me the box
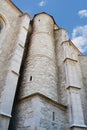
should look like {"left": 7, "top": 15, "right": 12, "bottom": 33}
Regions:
{"left": 0, "top": 0, "right": 30, "bottom": 130}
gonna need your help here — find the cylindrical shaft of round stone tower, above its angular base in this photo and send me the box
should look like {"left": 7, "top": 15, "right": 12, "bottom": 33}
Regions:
{"left": 20, "top": 13, "right": 58, "bottom": 101}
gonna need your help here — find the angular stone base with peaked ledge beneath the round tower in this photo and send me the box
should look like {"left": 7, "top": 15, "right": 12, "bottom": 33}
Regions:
{"left": 11, "top": 95, "right": 69, "bottom": 130}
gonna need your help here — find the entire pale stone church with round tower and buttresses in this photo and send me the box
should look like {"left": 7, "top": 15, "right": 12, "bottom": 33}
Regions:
{"left": 0, "top": 0, "right": 87, "bottom": 130}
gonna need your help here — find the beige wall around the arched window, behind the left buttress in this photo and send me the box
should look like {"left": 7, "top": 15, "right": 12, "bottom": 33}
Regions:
{"left": 0, "top": 0, "right": 21, "bottom": 95}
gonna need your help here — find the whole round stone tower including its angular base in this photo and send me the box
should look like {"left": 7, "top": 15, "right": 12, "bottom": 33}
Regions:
{"left": 9, "top": 13, "right": 68, "bottom": 130}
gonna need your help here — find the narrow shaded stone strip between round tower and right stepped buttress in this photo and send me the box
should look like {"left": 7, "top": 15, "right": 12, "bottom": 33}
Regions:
{"left": 54, "top": 28, "right": 69, "bottom": 105}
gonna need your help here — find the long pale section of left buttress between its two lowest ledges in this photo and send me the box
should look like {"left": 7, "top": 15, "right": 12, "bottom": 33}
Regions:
{"left": 0, "top": 72, "right": 18, "bottom": 115}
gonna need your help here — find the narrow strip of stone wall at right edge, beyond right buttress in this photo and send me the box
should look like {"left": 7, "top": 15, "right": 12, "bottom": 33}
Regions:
{"left": 79, "top": 55, "right": 87, "bottom": 128}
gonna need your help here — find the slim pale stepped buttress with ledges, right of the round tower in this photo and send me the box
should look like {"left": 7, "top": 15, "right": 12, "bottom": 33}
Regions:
{"left": 62, "top": 41, "right": 86, "bottom": 130}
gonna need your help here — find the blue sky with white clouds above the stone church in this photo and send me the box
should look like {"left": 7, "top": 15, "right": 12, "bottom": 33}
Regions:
{"left": 12, "top": 0, "right": 87, "bottom": 54}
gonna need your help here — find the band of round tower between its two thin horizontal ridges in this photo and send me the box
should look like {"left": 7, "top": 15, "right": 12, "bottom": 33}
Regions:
{"left": 29, "top": 33, "right": 55, "bottom": 60}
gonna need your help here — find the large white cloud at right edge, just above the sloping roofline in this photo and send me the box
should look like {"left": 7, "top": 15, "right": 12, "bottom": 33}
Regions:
{"left": 72, "top": 25, "right": 87, "bottom": 53}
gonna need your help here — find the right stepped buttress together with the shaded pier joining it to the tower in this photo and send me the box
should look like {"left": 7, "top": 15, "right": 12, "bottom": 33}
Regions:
{"left": 55, "top": 29, "right": 86, "bottom": 130}
